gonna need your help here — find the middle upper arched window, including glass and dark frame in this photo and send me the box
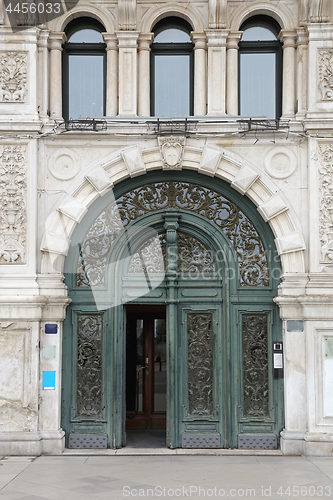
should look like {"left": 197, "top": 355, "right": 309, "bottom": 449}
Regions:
{"left": 151, "top": 17, "right": 193, "bottom": 117}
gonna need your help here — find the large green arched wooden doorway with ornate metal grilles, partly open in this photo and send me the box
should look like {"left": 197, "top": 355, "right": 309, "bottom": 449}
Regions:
{"left": 62, "top": 172, "right": 283, "bottom": 448}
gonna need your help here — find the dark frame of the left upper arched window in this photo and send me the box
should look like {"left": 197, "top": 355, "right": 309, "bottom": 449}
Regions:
{"left": 62, "top": 18, "right": 107, "bottom": 120}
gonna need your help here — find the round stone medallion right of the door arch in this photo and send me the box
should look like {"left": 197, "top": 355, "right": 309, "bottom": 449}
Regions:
{"left": 265, "top": 147, "right": 297, "bottom": 179}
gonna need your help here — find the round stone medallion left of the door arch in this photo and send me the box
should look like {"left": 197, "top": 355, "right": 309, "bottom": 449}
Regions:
{"left": 48, "top": 148, "right": 81, "bottom": 181}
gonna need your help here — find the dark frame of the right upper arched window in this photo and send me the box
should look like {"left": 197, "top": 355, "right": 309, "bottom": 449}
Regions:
{"left": 238, "top": 16, "right": 283, "bottom": 120}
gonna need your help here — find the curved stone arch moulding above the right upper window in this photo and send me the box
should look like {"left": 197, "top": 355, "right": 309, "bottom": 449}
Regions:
{"left": 230, "top": 1, "right": 297, "bottom": 31}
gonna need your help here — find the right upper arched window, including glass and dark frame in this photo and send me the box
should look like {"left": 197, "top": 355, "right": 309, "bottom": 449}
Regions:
{"left": 239, "top": 16, "right": 282, "bottom": 119}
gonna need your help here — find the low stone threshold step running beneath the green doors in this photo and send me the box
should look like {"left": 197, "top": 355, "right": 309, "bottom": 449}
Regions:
{"left": 61, "top": 447, "right": 285, "bottom": 457}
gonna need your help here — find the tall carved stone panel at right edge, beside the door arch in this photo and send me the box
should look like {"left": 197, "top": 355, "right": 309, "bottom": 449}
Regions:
{"left": 319, "top": 145, "right": 333, "bottom": 264}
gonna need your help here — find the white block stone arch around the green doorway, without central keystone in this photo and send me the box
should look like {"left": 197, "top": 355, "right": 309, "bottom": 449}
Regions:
{"left": 41, "top": 144, "right": 305, "bottom": 274}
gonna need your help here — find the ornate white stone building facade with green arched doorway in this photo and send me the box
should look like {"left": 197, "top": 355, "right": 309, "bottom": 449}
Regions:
{"left": 0, "top": 0, "right": 333, "bottom": 455}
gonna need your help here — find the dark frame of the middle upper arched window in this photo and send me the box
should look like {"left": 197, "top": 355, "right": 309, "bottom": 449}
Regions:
{"left": 150, "top": 18, "right": 194, "bottom": 118}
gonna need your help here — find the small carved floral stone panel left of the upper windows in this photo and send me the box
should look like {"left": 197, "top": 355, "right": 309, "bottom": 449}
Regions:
{"left": 0, "top": 51, "right": 28, "bottom": 103}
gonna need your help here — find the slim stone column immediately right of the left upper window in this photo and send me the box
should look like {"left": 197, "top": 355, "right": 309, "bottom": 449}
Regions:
{"left": 102, "top": 33, "right": 118, "bottom": 116}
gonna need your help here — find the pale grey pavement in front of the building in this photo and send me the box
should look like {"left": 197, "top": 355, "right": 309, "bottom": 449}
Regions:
{"left": 0, "top": 458, "right": 333, "bottom": 500}
